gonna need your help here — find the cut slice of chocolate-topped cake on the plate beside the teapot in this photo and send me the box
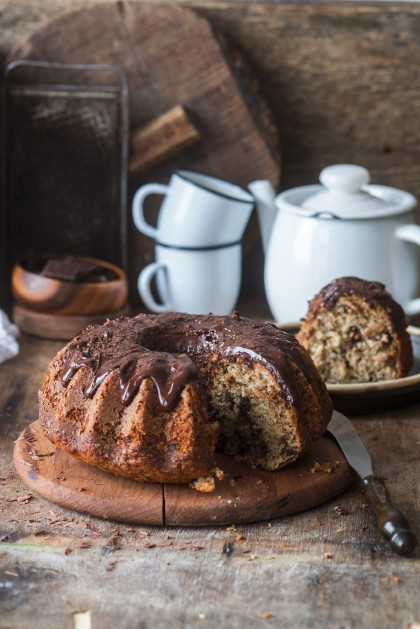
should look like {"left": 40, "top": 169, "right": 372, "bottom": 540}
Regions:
{"left": 296, "top": 277, "right": 413, "bottom": 384}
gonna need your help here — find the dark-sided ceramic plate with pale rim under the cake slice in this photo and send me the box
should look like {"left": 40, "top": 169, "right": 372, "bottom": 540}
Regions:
{"left": 277, "top": 322, "right": 420, "bottom": 414}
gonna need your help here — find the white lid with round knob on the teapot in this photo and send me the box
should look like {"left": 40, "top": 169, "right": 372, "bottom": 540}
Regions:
{"left": 278, "top": 164, "right": 416, "bottom": 219}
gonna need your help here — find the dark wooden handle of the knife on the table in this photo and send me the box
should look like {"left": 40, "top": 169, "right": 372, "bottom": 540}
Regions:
{"left": 362, "top": 474, "right": 417, "bottom": 555}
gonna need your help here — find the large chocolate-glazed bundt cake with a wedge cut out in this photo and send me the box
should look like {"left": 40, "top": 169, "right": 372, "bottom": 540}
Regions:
{"left": 39, "top": 312, "right": 332, "bottom": 483}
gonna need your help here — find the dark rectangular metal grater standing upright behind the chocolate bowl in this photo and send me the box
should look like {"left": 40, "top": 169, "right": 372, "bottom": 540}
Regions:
{"left": 1, "top": 60, "right": 129, "bottom": 305}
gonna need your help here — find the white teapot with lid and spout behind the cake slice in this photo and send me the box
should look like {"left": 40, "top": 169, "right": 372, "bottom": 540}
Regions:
{"left": 249, "top": 164, "right": 420, "bottom": 322}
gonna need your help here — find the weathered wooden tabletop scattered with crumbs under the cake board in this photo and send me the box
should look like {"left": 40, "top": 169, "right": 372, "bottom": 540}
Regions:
{"left": 0, "top": 336, "right": 420, "bottom": 629}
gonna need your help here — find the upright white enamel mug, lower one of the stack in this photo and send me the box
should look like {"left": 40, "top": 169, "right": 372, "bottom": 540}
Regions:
{"left": 137, "top": 244, "right": 242, "bottom": 315}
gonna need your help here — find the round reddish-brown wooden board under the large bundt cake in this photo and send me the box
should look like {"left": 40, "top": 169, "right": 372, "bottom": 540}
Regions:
{"left": 14, "top": 421, "right": 356, "bottom": 526}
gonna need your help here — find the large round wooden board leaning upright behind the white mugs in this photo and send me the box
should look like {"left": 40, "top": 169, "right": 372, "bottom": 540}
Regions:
{"left": 7, "top": 0, "right": 280, "bottom": 301}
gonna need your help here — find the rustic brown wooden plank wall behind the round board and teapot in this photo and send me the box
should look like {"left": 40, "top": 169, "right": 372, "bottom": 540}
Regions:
{"left": 0, "top": 0, "right": 420, "bottom": 310}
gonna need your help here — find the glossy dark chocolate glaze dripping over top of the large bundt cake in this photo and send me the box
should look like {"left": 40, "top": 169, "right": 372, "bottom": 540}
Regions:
{"left": 60, "top": 313, "right": 313, "bottom": 410}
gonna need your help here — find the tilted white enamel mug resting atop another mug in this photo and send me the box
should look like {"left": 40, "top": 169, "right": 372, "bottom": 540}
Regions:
{"left": 132, "top": 170, "right": 255, "bottom": 247}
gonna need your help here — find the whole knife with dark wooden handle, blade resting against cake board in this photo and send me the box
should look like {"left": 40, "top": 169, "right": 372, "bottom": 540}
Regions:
{"left": 327, "top": 411, "right": 417, "bottom": 555}
